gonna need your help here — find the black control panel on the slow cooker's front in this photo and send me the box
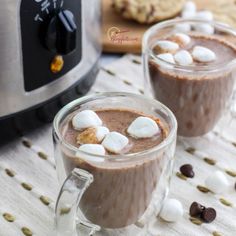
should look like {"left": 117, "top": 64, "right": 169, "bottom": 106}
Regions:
{"left": 20, "top": 0, "right": 82, "bottom": 91}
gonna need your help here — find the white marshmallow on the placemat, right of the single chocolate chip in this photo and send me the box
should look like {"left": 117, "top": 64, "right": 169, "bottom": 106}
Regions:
{"left": 205, "top": 170, "right": 229, "bottom": 193}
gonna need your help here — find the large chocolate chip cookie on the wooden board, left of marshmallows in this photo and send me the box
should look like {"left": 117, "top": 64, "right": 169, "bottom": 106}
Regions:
{"left": 112, "top": 0, "right": 185, "bottom": 24}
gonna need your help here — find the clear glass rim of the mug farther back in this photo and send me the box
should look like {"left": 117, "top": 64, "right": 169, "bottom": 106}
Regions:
{"left": 142, "top": 18, "right": 236, "bottom": 73}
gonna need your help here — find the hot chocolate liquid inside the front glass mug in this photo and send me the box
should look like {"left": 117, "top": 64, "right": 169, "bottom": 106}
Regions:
{"left": 62, "top": 110, "right": 168, "bottom": 228}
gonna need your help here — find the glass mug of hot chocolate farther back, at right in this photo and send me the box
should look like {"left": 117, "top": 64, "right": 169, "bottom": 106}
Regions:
{"left": 143, "top": 19, "right": 236, "bottom": 137}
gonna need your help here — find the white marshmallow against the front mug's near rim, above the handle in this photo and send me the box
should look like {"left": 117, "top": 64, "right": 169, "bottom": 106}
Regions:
{"left": 75, "top": 144, "right": 106, "bottom": 162}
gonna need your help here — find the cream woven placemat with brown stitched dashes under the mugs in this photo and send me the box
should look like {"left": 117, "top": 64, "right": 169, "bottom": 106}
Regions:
{"left": 0, "top": 55, "right": 236, "bottom": 236}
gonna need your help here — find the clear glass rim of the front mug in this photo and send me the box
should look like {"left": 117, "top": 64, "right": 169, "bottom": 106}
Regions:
{"left": 53, "top": 92, "right": 178, "bottom": 161}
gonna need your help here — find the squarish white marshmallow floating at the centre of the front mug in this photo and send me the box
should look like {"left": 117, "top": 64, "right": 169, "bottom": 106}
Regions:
{"left": 102, "top": 132, "right": 129, "bottom": 153}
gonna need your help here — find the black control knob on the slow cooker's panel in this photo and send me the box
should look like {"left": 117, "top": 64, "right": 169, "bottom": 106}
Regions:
{"left": 45, "top": 10, "right": 77, "bottom": 55}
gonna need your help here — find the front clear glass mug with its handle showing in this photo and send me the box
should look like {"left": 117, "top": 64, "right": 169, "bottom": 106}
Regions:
{"left": 53, "top": 93, "right": 177, "bottom": 236}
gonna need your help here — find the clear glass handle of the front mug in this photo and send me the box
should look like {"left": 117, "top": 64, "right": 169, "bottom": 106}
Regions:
{"left": 55, "top": 168, "right": 100, "bottom": 236}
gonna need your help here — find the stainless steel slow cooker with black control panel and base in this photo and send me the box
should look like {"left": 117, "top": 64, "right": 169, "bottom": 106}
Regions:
{"left": 0, "top": 0, "right": 101, "bottom": 143}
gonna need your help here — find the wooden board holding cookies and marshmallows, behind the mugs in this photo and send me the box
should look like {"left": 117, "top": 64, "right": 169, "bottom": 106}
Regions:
{"left": 102, "top": 0, "right": 236, "bottom": 53}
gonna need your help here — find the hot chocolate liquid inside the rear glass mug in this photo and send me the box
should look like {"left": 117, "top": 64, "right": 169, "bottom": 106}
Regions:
{"left": 149, "top": 35, "right": 236, "bottom": 137}
